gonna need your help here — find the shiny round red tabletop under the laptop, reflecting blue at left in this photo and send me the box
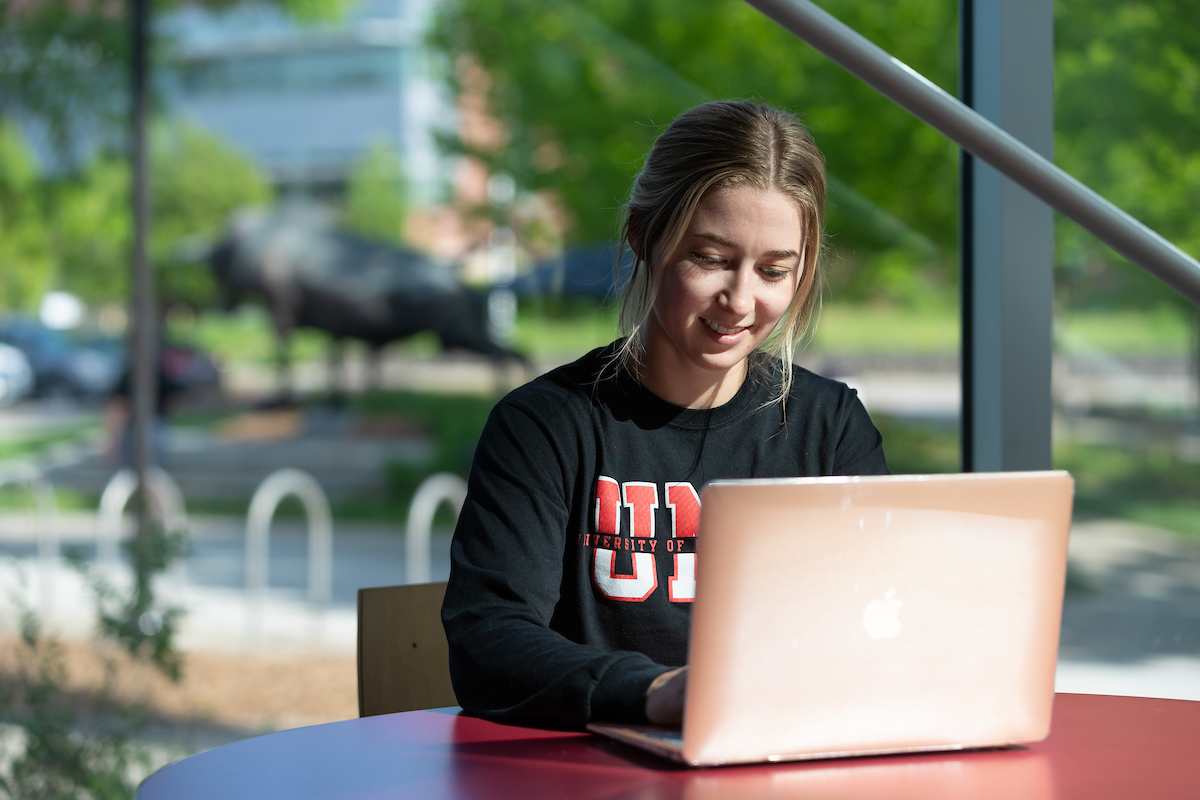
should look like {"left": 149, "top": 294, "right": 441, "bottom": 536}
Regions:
{"left": 138, "top": 694, "right": 1200, "bottom": 800}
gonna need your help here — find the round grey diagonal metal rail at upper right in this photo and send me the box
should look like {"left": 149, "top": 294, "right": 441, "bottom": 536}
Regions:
{"left": 746, "top": 0, "right": 1200, "bottom": 306}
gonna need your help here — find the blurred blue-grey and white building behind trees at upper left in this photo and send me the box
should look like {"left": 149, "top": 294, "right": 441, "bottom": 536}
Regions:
{"left": 156, "top": 0, "right": 457, "bottom": 205}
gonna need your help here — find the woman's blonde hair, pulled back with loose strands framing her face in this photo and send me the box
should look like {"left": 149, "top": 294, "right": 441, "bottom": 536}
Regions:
{"left": 617, "top": 101, "right": 826, "bottom": 402}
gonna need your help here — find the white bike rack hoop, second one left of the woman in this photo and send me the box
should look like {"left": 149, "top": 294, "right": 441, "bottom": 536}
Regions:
{"left": 246, "top": 468, "right": 334, "bottom": 636}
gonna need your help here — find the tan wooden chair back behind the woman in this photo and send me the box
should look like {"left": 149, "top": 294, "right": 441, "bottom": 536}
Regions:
{"left": 358, "top": 582, "right": 457, "bottom": 717}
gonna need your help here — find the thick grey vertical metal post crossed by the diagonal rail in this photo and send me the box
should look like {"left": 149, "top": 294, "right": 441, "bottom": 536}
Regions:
{"left": 960, "top": 0, "right": 1054, "bottom": 471}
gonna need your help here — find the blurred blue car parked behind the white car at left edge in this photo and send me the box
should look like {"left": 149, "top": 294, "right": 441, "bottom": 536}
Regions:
{"left": 0, "top": 317, "right": 121, "bottom": 397}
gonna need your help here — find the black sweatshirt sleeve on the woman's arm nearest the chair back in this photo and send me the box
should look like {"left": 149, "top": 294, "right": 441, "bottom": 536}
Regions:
{"left": 442, "top": 393, "right": 666, "bottom": 729}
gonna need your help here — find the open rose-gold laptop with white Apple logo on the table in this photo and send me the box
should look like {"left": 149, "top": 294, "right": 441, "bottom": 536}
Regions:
{"left": 589, "top": 471, "right": 1074, "bottom": 766}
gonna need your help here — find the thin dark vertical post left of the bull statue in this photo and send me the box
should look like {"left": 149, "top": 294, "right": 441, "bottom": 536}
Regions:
{"left": 130, "top": 0, "right": 158, "bottom": 536}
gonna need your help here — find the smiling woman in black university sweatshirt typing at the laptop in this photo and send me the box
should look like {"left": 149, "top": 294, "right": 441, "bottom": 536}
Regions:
{"left": 442, "top": 102, "right": 887, "bottom": 728}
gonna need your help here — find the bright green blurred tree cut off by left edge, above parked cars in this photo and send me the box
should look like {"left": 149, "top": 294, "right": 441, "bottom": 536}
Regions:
{"left": 0, "top": 119, "right": 50, "bottom": 312}
